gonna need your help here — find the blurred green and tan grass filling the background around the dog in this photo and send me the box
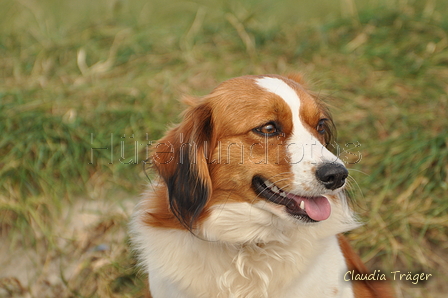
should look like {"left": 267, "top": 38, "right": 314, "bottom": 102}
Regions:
{"left": 0, "top": 0, "right": 448, "bottom": 297}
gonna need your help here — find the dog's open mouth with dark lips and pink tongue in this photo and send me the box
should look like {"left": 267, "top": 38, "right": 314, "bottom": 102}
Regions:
{"left": 252, "top": 176, "right": 331, "bottom": 222}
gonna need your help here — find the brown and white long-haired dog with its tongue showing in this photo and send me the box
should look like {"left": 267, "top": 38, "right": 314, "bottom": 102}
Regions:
{"left": 131, "top": 75, "right": 393, "bottom": 298}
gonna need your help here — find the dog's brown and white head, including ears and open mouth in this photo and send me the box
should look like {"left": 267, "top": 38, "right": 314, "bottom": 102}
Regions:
{"left": 153, "top": 76, "right": 354, "bottom": 242}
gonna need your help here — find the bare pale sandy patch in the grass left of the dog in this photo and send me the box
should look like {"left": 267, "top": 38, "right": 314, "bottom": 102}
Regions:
{"left": 0, "top": 198, "right": 138, "bottom": 298}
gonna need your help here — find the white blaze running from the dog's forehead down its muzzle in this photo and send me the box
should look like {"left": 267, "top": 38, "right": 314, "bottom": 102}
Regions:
{"left": 256, "top": 77, "right": 342, "bottom": 193}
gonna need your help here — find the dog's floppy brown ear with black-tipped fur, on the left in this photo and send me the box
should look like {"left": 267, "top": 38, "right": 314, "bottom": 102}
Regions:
{"left": 153, "top": 101, "right": 215, "bottom": 229}
